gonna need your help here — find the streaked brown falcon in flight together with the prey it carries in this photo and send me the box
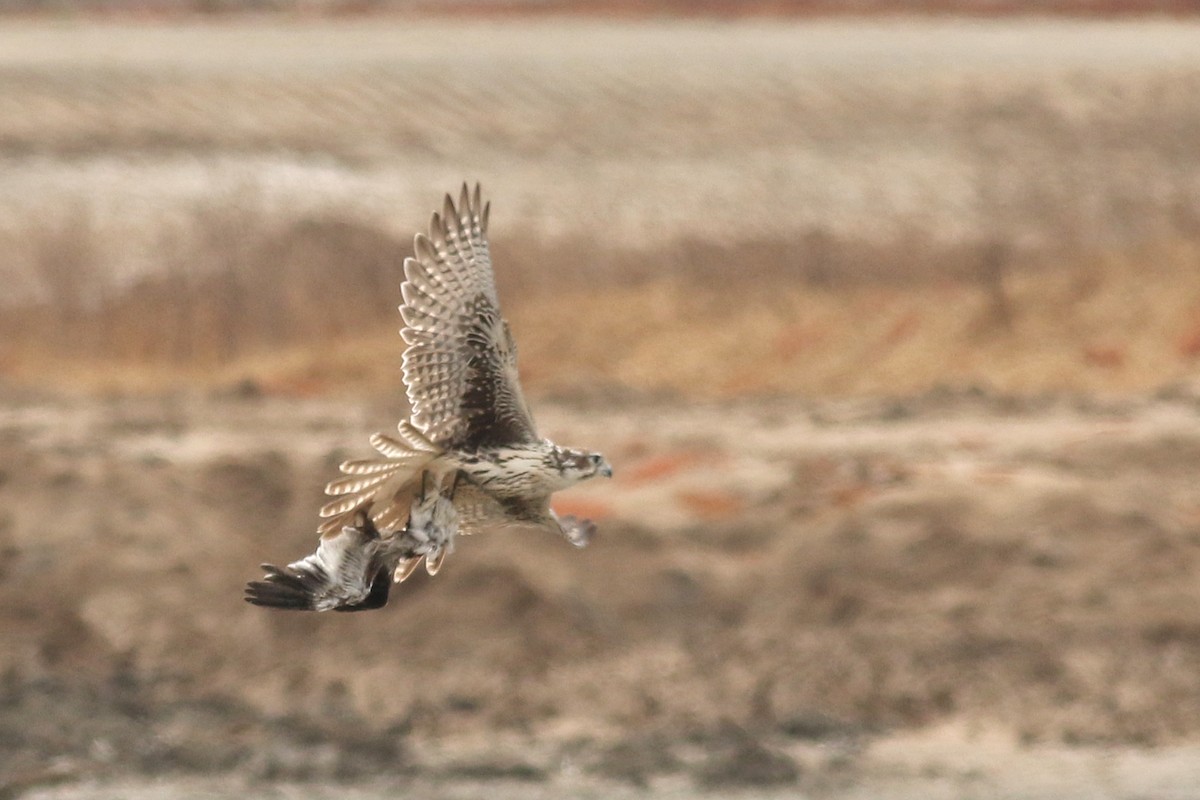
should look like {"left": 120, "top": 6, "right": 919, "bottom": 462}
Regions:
{"left": 246, "top": 184, "right": 612, "bottom": 612}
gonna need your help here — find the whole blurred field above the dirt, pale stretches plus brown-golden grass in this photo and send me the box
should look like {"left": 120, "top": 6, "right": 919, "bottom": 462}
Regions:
{"left": 0, "top": 22, "right": 1200, "bottom": 395}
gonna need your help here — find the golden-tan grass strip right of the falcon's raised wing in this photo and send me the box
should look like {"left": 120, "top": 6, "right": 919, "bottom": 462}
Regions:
{"left": 504, "top": 243, "right": 1200, "bottom": 396}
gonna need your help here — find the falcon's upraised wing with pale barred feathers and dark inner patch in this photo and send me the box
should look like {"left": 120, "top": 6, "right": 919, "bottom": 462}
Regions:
{"left": 400, "top": 184, "right": 538, "bottom": 450}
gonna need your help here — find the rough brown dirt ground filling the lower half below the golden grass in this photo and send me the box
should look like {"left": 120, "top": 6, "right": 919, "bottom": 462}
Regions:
{"left": 7, "top": 387, "right": 1200, "bottom": 798}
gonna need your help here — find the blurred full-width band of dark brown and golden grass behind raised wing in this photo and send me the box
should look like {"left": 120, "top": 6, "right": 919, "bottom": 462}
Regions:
{"left": 7, "top": 200, "right": 1200, "bottom": 396}
